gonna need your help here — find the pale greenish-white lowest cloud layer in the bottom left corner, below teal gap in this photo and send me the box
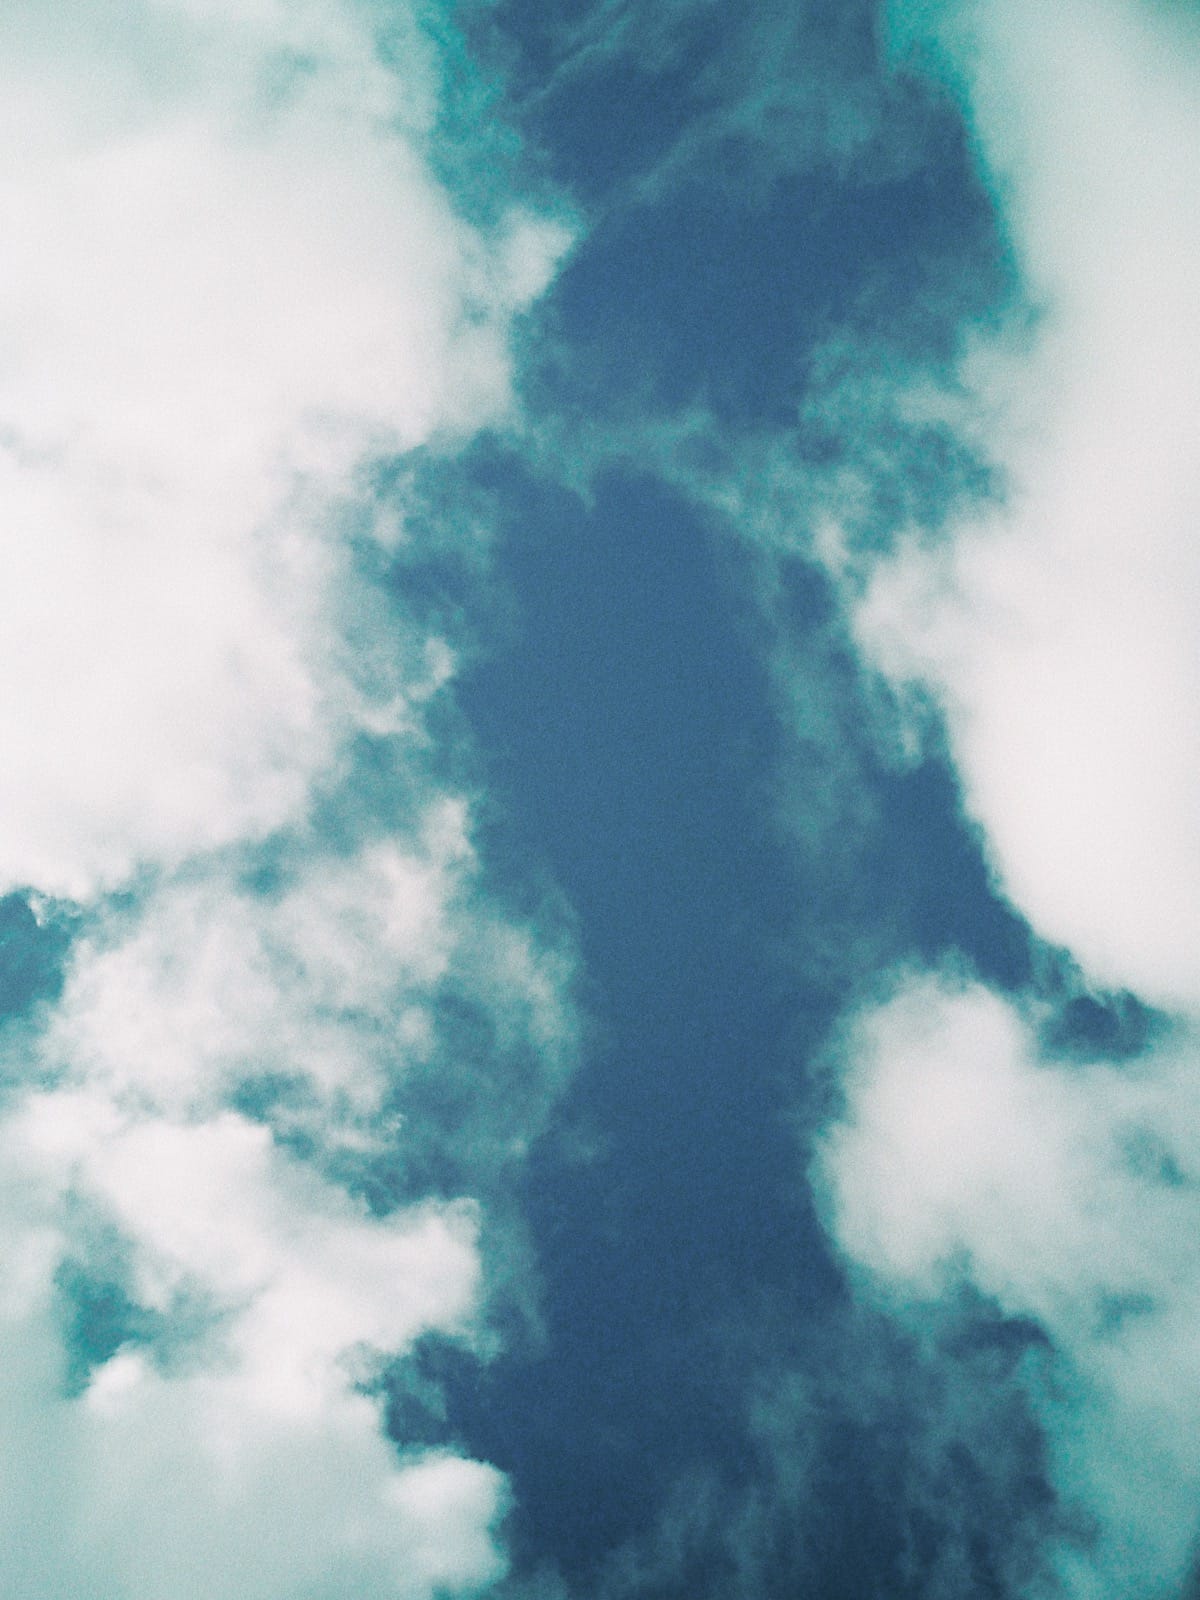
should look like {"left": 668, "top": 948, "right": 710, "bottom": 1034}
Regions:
{"left": 0, "top": 1299, "right": 504, "bottom": 1600}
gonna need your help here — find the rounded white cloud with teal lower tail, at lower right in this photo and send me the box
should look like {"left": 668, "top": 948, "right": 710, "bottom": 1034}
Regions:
{"left": 818, "top": 974, "right": 1200, "bottom": 1597}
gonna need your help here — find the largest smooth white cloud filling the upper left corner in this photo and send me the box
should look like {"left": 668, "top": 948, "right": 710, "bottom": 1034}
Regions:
{"left": 0, "top": 3, "right": 565, "bottom": 896}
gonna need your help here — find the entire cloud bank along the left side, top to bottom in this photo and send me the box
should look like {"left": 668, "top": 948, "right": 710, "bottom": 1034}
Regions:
{"left": 0, "top": 0, "right": 573, "bottom": 1600}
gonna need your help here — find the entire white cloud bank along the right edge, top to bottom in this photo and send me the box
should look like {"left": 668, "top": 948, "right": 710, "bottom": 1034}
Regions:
{"left": 816, "top": 0, "right": 1200, "bottom": 1600}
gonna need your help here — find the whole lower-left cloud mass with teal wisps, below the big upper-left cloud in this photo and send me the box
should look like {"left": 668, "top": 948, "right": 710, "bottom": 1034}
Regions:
{"left": 0, "top": 798, "right": 571, "bottom": 1600}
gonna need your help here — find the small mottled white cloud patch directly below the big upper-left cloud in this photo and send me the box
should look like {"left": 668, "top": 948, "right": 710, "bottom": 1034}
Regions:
{"left": 42, "top": 800, "right": 472, "bottom": 1128}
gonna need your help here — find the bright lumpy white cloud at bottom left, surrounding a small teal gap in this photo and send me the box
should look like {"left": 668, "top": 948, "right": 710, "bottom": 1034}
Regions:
{"left": 0, "top": 1093, "right": 504, "bottom": 1600}
